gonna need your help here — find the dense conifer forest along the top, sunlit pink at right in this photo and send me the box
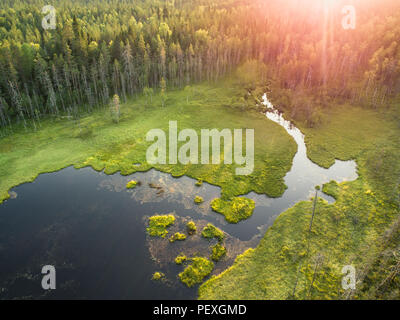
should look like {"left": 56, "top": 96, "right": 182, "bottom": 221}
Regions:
{"left": 0, "top": 0, "right": 400, "bottom": 134}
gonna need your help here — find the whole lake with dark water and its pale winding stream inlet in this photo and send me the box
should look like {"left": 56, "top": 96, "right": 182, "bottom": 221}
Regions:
{"left": 0, "top": 95, "right": 357, "bottom": 299}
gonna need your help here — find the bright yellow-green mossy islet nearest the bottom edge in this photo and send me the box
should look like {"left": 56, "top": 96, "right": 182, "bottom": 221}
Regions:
{"left": 179, "top": 257, "right": 214, "bottom": 288}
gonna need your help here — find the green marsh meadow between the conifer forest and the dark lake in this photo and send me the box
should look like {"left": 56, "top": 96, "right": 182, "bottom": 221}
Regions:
{"left": 0, "top": 80, "right": 297, "bottom": 202}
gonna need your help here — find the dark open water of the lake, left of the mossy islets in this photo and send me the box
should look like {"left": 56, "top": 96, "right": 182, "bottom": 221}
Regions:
{"left": 0, "top": 167, "right": 194, "bottom": 299}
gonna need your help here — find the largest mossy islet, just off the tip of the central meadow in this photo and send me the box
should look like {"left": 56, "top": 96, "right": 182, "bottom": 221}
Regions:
{"left": 211, "top": 197, "right": 255, "bottom": 223}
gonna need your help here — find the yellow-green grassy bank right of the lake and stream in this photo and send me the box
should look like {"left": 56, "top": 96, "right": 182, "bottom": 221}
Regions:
{"left": 199, "top": 102, "right": 400, "bottom": 300}
